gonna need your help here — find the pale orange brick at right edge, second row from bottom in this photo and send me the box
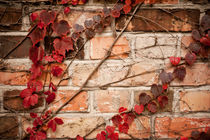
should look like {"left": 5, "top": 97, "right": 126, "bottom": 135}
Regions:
{"left": 179, "top": 90, "right": 210, "bottom": 112}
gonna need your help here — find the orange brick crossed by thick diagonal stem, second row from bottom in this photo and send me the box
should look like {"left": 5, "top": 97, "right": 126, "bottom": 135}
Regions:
{"left": 50, "top": 90, "right": 88, "bottom": 112}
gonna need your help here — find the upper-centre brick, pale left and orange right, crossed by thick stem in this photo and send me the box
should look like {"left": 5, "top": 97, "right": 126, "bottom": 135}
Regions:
{"left": 90, "top": 37, "right": 130, "bottom": 59}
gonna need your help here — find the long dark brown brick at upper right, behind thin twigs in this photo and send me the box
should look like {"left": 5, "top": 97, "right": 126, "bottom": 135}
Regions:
{"left": 116, "top": 9, "right": 200, "bottom": 32}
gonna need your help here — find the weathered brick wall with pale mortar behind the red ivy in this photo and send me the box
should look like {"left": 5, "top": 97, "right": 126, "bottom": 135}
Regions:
{"left": 0, "top": 0, "right": 210, "bottom": 139}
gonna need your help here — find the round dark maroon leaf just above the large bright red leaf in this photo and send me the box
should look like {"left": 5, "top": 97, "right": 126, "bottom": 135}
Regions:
{"left": 52, "top": 20, "right": 70, "bottom": 36}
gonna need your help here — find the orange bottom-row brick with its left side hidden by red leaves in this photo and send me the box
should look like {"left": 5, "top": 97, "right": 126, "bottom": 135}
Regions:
{"left": 119, "top": 116, "right": 151, "bottom": 139}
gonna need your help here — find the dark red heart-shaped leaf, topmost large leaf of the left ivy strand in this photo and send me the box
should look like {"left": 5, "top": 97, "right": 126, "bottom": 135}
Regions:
{"left": 40, "top": 10, "right": 56, "bottom": 26}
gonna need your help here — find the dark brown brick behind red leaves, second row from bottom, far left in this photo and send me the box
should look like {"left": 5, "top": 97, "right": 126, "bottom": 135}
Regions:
{"left": 3, "top": 90, "right": 44, "bottom": 111}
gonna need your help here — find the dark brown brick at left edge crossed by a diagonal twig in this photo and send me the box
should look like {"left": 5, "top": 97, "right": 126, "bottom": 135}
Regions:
{"left": 0, "top": 36, "right": 32, "bottom": 58}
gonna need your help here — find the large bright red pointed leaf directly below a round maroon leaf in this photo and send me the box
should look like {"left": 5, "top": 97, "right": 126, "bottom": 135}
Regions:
{"left": 53, "top": 37, "right": 74, "bottom": 57}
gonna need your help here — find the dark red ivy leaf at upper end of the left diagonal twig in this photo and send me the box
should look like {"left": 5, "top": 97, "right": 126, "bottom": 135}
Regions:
{"left": 29, "top": 28, "right": 46, "bottom": 46}
